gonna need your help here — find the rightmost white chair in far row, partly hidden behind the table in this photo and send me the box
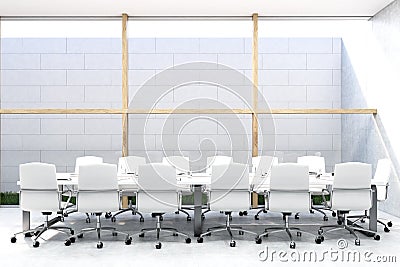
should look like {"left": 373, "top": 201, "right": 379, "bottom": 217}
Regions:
{"left": 295, "top": 156, "right": 328, "bottom": 221}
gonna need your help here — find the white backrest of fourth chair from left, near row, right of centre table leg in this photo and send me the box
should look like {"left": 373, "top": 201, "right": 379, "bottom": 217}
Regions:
{"left": 209, "top": 162, "right": 250, "bottom": 211}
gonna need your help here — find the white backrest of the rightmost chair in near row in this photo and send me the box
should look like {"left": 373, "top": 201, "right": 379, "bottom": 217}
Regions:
{"left": 332, "top": 162, "right": 372, "bottom": 211}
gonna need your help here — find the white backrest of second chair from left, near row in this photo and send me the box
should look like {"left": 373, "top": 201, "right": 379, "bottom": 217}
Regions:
{"left": 77, "top": 163, "right": 119, "bottom": 213}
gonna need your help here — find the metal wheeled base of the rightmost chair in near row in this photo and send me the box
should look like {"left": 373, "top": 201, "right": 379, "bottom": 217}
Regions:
{"left": 315, "top": 211, "right": 380, "bottom": 246}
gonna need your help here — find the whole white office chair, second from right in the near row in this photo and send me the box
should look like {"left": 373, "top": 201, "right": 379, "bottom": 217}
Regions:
{"left": 257, "top": 163, "right": 310, "bottom": 249}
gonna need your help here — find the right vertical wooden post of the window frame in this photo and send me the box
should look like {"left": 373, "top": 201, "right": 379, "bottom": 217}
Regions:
{"left": 251, "top": 13, "right": 258, "bottom": 208}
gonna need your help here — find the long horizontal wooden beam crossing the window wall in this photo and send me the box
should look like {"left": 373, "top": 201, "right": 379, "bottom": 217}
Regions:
{"left": 0, "top": 108, "right": 378, "bottom": 115}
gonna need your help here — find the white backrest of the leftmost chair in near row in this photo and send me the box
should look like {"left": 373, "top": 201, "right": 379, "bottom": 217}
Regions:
{"left": 19, "top": 162, "right": 59, "bottom": 212}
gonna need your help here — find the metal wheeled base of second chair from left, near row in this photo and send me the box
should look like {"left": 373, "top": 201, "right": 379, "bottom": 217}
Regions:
{"left": 65, "top": 213, "right": 132, "bottom": 249}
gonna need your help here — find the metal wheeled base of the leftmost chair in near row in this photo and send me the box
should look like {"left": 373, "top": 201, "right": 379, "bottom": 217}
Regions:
{"left": 11, "top": 213, "right": 74, "bottom": 247}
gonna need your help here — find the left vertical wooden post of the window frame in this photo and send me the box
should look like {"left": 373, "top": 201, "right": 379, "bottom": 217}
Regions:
{"left": 122, "top": 14, "right": 128, "bottom": 208}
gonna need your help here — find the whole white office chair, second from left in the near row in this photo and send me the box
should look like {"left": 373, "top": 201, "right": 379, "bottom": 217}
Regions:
{"left": 66, "top": 163, "right": 132, "bottom": 249}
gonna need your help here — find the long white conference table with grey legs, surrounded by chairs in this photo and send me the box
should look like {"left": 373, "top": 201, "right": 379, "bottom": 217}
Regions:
{"left": 17, "top": 173, "right": 377, "bottom": 237}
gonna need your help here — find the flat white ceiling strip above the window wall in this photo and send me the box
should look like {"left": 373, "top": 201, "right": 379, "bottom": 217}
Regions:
{"left": 0, "top": 0, "right": 393, "bottom": 16}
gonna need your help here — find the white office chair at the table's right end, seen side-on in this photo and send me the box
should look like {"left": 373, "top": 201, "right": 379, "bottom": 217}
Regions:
{"left": 347, "top": 159, "right": 393, "bottom": 232}
